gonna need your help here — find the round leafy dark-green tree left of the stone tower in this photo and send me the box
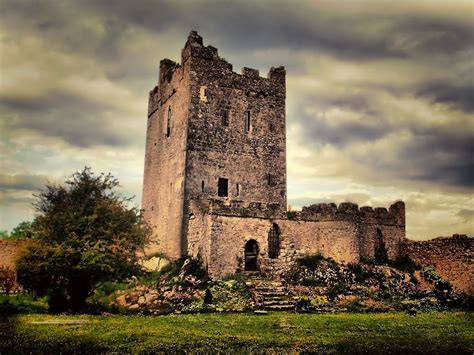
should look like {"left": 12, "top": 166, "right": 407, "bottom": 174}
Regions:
{"left": 16, "top": 167, "right": 149, "bottom": 312}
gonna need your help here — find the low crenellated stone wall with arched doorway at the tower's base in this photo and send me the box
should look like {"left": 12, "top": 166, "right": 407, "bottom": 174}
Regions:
{"left": 189, "top": 200, "right": 405, "bottom": 277}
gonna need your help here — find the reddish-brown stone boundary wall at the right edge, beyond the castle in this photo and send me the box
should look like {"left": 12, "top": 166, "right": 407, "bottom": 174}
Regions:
{"left": 403, "top": 234, "right": 474, "bottom": 295}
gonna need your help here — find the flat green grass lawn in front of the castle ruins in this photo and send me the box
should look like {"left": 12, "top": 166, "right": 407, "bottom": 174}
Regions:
{"left": 0, "top": 313, "right": 474, "bottom": 354}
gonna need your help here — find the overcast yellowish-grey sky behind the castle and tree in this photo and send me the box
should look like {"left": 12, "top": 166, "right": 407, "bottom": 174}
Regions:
{"left": 0, "top": 0, "right": 474, "bottom": 239}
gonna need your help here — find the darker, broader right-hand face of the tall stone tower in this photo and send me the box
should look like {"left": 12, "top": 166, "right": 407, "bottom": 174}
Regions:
{"left": 182, "top": 33, "right": 286, "bottom": 220}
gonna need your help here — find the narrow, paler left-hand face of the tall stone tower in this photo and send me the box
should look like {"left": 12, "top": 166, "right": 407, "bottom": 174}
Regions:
{"left": 142, "top": 53, "right": 190, "bottom": 258}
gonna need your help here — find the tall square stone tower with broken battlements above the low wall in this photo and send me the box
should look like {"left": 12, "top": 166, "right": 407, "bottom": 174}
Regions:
{"left": 142, "top": 31, "right": 287, "bottom": 259}
